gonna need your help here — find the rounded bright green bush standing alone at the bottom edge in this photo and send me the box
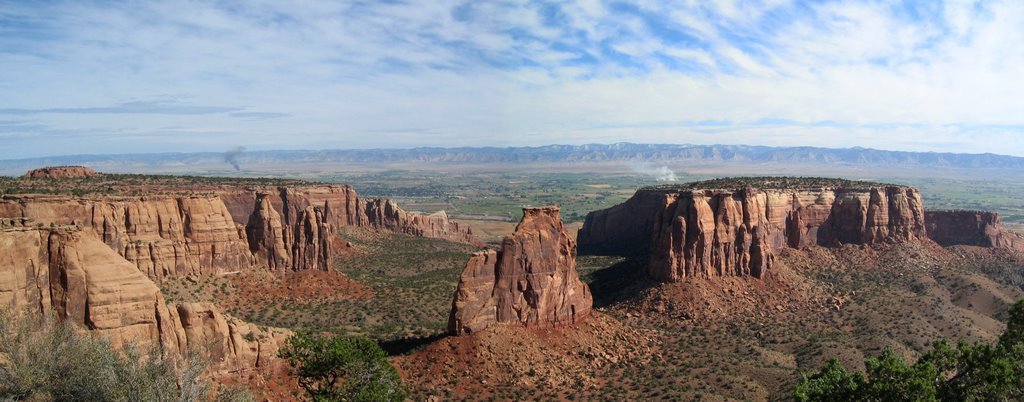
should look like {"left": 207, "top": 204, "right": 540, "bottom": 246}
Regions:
{"left": 281, "top": 333, "right": 409, "bottom": 401}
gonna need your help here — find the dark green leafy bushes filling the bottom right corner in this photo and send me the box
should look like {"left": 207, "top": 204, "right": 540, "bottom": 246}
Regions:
{"left": 794, "top": 300, "right": 1024, "bottom": 401}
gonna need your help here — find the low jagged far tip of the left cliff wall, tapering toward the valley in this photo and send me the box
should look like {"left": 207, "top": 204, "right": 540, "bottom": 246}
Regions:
{"left": 366, "top": 198, "right": 476, "bottom": 243}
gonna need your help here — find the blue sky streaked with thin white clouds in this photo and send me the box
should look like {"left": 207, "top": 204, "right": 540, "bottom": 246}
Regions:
{"left": 0, "top": 0, "right": 1024, "bottom": 159}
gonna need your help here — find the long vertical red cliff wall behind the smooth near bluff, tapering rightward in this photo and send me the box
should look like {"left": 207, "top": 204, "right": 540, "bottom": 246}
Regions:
{"left": 0, "top": 185, "right": 475, "bottom": 281}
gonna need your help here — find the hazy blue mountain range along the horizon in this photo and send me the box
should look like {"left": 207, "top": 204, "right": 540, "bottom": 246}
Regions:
{"left": 0, "top": 143, "right": 1024, "bottom": 175}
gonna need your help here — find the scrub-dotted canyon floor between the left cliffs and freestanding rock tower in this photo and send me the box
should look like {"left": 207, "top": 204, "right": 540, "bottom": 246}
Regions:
{"left": 161, "top": 228, "right": 475, "bottom": 342}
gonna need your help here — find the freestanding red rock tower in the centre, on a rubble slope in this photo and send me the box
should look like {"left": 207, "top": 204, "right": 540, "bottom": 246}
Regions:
{"left": 449, "top": 207, "right": 593, "bottom": 334}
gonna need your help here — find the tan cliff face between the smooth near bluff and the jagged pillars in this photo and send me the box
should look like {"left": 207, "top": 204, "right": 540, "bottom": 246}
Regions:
{"left": 0, "top": 195, "right": 254, "bottom": 281}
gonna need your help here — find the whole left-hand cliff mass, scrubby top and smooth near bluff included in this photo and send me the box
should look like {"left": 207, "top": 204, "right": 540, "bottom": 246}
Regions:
{"left": 0, "top": 167, "right": 478, "bottom": 373}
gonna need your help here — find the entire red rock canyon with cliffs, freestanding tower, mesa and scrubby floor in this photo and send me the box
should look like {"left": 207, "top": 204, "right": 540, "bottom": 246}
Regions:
{"left": 0, "top": 170, "right": 1022, "bottom": 400}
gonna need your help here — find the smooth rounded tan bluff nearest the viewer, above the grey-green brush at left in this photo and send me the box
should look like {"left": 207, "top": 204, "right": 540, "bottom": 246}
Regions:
{"left": 0, "top": 228, "right": 289, "bottom": 371}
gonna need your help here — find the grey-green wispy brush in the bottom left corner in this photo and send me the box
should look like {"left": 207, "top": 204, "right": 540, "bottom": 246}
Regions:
{"left": 0, "top": 318, "right": 223, "bottom": 401}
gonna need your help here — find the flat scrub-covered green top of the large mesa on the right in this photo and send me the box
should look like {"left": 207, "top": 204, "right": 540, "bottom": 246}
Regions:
{"left": 640, "top": 176, "right": 906, "bottom": 192}
